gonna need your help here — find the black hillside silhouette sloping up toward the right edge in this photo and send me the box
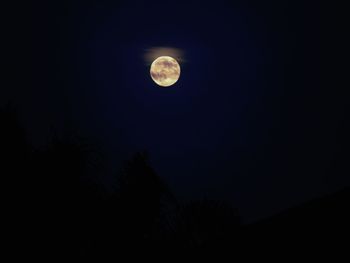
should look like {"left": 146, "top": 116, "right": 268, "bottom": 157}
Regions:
{"left": 243, "top": 188, "right": 350, "bottom": 254}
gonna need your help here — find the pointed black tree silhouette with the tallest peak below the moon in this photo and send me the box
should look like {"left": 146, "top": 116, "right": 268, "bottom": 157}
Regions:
{"left": 92, "top": 153, "right": 174, "bottom": 258}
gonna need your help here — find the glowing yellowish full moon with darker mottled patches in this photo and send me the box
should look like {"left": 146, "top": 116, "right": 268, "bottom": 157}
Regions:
{"left": 150, "top": 56, "right": 180, "bottom": 87}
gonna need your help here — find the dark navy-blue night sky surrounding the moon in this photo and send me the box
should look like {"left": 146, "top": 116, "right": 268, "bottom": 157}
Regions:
{"left": 0, "top": 0, "right": 350, "bottom": 222}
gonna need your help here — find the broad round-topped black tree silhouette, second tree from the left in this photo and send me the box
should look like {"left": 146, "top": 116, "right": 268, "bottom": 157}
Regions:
{"left": 24, "top": 129, "right": 102, "bottom": 255}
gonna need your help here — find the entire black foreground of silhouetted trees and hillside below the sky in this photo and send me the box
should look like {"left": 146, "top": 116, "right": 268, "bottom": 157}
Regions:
{"left": 0, "top": 108, "right": 350, "bottom": 262}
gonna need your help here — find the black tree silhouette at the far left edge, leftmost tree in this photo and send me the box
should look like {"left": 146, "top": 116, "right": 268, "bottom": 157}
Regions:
{"left": 0, "top": 107, "right": 33, "bottom": 258}
